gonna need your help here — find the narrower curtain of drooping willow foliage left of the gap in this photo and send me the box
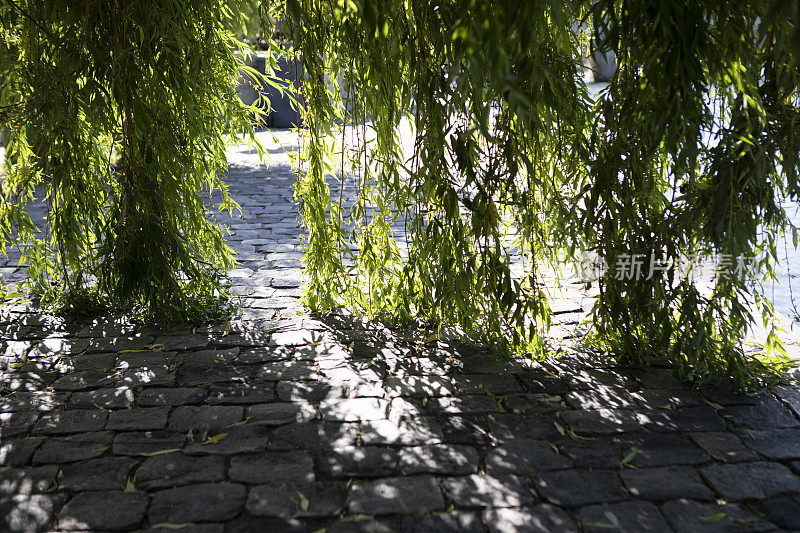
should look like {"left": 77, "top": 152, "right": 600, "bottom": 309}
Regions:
{"left": 0, "top": 0, "right": 260, "bottom": 320}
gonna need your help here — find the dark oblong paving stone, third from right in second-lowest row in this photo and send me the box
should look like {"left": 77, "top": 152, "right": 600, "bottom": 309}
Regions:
{"left": 534, "top": 470, "right": 627, "bottom": 507}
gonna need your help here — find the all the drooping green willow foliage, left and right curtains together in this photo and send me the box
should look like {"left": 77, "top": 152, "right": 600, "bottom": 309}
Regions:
{"left": 0, "top": 0, "right": 800, "bottom": 384}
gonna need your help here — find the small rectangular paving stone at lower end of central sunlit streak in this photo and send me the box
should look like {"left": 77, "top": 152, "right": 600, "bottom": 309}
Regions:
{"left": 397, "top": 444, "right": 480, "bottom": 475}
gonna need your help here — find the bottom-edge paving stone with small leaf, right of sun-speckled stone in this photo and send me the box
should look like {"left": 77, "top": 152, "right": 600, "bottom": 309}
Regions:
{"left": 576, "top": 501, "right": 672, "bottom": 533}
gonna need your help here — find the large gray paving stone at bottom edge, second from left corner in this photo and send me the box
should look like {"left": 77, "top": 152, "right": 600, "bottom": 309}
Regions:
{"left": 58, "top": 491, "right": 147, "bottom": 531}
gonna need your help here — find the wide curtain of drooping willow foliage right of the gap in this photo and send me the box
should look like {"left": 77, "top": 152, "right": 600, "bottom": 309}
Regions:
{"left": 262, "top": 0, "right": 800, "bottom": 384}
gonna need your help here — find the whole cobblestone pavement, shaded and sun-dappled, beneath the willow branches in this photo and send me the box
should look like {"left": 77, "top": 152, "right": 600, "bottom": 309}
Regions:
{"left": 0, "top": 135, "right": 800, "bottom": 533}
